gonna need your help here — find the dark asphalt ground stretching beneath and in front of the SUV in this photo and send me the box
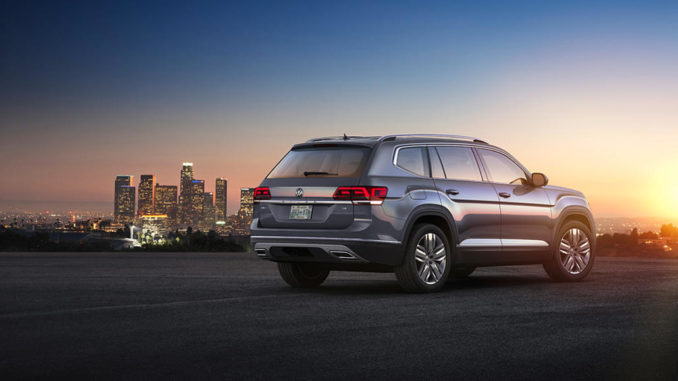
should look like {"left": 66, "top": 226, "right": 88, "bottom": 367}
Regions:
{"left": 0, "top": 253, "right": 678, "bottom": 380}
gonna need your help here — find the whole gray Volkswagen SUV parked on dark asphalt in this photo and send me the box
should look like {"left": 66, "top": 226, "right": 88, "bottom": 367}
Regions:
{"left": 251, "top": 135, "right": 595, "bottom": 292}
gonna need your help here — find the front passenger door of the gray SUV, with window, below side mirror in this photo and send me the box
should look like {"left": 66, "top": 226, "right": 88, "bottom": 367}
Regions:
{"left": 476, "top": 148, "right": 551, "bottom": 252}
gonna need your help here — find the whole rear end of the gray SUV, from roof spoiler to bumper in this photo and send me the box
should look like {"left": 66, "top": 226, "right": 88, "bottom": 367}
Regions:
{"left": 251, "top": 139, "right": 402, "bottom": 271}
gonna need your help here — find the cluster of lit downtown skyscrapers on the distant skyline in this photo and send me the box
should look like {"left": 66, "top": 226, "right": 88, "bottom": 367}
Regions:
{"left": 112, "top": 163, "right": 254, "bottom": 237}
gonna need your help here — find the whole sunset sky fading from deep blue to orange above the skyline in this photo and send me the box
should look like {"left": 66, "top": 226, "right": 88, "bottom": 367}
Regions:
{"left": 0, "top": 1, "right": 678, "bottom": 218}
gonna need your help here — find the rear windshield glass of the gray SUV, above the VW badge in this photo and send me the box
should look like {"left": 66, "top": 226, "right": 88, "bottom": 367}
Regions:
{"left": 268, "top": 147, "right": 370, "bottom": 179}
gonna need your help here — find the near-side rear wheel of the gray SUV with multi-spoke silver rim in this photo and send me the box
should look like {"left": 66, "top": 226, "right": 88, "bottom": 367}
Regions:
{"left": 395, "top": 224, "right": 453, "bottom": 292}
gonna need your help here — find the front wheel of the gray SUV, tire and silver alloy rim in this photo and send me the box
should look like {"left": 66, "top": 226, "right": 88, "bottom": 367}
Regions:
{"left": 544, "top": 221, "right": 595, "bottom": 282}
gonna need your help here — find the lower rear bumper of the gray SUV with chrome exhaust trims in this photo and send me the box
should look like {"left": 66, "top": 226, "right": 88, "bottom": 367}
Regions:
{"left": 251, "top": 235, "right": 404, "bottom": 267}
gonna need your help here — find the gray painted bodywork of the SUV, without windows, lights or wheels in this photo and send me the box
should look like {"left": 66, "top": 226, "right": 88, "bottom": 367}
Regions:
{"left": 252, "top": 137, "right": 595, "bottom": 265}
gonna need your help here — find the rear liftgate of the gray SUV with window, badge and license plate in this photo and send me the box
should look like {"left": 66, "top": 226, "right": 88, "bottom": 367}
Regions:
{"left": 257, "top": 144, "right": 371, "bottom": 229}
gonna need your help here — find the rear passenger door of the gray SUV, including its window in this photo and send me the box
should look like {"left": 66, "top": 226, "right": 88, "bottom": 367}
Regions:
{"left": 428, "top": 145, "right": 501, "bottom": 255}
